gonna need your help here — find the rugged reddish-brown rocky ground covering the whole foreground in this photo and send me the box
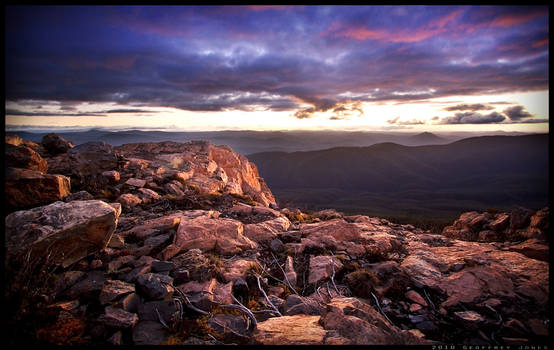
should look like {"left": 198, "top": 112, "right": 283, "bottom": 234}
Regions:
{"left": 5, "top": 136, "right": 549, "bottom": 345}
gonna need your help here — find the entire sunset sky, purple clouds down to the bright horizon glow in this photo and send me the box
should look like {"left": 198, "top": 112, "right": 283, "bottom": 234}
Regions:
{"left": 5, "top": 5, "right": 549, "bottom": 132}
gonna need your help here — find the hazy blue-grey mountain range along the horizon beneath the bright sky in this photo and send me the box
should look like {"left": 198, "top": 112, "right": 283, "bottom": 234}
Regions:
{"left": 8, "top": 129, "right": 498, "bottom": 154}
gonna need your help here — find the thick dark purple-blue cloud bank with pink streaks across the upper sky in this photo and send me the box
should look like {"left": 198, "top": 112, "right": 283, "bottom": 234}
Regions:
{"left": 5, "top": 6, "right": 548, "bottom": 121}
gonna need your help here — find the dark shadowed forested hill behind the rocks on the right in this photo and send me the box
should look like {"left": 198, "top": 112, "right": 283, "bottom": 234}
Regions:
{"left": 248, "top": 134, "right": 549, "bottom": 218}
